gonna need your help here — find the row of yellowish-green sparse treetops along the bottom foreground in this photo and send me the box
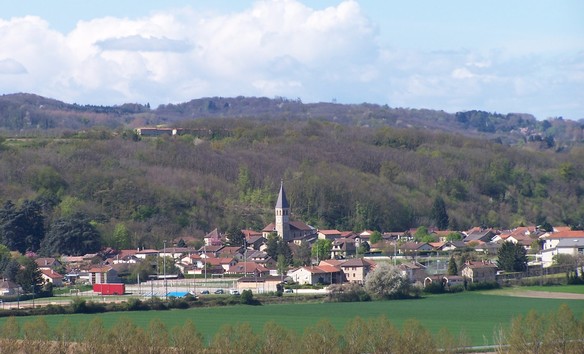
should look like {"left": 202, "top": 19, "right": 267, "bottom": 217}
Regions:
{"left": 0, "top": 305, "right": 584, "bottom": 354}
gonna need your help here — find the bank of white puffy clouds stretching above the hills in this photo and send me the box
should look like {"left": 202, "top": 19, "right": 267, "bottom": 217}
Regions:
{"left": 0, "top": 0, "right": 584, "bottom": 119}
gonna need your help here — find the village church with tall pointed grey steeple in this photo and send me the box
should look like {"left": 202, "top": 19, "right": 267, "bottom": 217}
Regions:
{"left": 262, "top": 181, "right": 316, "bottom": 243}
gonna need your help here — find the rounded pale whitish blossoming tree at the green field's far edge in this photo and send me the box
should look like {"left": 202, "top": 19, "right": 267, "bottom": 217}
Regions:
{"left": 365, "top": 263, "right": 410, "bottom": 299}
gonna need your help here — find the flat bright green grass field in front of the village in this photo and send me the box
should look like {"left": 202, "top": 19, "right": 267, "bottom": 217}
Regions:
{"left": 0, "top": 292, "right": 584, "bottom": 345}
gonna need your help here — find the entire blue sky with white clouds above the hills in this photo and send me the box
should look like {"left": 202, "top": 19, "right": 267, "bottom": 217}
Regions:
{"left": 0, "top": 0, "right": 584, "bottom": 119}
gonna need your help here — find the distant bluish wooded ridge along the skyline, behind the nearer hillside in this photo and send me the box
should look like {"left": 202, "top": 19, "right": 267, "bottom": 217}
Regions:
{"left": 0, "top": 94, "right": 584, "bottom": 150}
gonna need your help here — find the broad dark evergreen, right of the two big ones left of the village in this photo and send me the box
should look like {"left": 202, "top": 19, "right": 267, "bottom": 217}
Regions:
{"left": 41, "top": 213, "right": 101, "bottom": 256}
